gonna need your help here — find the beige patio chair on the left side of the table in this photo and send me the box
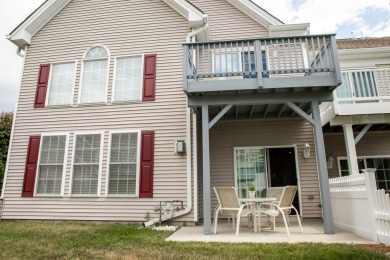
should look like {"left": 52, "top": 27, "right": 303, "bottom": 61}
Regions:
{"left": 213, "top": 187, "right": 254, "bottom": 236}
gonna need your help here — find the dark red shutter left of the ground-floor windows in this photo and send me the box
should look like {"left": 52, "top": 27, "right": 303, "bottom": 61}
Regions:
{"left": 22, "top": 136, "right": 41, "bottom": 197}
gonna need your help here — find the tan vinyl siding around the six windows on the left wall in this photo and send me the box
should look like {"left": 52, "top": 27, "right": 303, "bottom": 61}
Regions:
{"left": 3, "top": 0, "right": 193, "bottom": 222}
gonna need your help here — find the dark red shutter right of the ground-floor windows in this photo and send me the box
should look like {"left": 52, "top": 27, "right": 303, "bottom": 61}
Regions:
{"left": 139, "top": 131, "right": 154, "bottom": 198}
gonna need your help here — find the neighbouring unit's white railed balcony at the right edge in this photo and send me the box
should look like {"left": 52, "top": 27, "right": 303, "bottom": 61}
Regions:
{"left": 321, "top": 68, "right": 390, "bottom": 125}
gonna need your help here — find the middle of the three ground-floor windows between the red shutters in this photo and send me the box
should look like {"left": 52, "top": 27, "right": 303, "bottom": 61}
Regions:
{"left": 70, "top": 133, "right": 104, "bottom": 196}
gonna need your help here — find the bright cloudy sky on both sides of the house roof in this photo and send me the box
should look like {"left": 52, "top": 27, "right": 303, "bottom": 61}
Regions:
{"left": 0, "top": 0, "right": 390, "bottom": 112}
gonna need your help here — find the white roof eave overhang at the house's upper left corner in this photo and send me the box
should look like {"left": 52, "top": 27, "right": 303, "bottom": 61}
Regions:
{"left": 7, "top": 0, "right": 71, "bottom": 48}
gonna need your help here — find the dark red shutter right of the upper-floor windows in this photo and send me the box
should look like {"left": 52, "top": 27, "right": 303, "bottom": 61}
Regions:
{"left": 142, "top": 54, "right": 157, "bottom": 101}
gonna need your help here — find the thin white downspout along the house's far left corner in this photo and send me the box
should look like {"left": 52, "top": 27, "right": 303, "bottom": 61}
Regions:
{"left": 0, "top": 45, "right": 28, "bottom": 200}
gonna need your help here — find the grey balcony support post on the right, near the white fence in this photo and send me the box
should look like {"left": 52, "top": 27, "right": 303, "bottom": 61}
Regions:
{"left": 311, "top": 101, "right": 334, "bottom": 234}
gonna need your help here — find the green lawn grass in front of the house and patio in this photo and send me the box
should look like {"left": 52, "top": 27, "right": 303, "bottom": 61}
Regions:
{"left": 0, "top": 221, "right": 385, "bottom": 260}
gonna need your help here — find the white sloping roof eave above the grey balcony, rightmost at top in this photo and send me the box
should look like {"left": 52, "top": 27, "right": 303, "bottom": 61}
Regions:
{"left": 226, "top": 0, "right": 283, "bottom": 28}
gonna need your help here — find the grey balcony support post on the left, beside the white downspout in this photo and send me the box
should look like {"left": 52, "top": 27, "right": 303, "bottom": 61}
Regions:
{"left": 202, "top": 105, "right": 211, "bottom": 235}
